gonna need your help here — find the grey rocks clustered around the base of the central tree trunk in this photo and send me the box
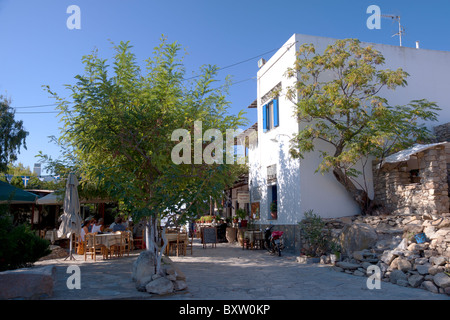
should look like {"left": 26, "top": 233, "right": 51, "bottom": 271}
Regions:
{"left": 132, "top": 251, "right": 187, "bottom": 295}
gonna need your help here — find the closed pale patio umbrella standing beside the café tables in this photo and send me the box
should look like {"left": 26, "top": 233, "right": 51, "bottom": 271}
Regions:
{"left": 58, "top": 173, "right": 81, "bottom": 260}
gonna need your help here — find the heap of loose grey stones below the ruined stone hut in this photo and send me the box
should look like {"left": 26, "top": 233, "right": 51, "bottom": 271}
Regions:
{"left": 322, "top": 214, "right": 450, "bottom": 295}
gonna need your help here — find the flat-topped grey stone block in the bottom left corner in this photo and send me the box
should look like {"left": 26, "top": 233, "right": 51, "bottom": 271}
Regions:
{"left": 0, "top": 265, "right": 56, "bottom": 300}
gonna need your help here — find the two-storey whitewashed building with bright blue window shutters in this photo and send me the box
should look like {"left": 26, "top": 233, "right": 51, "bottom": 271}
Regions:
{"left": 249, "top": 34, "right": 450, "bottom": 249}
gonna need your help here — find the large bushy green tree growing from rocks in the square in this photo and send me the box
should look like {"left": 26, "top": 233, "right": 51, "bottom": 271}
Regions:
{"left": 48, "top": 39, "right": 245, "bottom": 270}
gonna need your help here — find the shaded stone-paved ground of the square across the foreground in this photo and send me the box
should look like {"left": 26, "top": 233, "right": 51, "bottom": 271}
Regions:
{"left": 36, "top": 240, "right": 450, "bottom": 300}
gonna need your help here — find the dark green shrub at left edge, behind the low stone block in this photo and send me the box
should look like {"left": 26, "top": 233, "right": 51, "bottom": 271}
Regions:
{"left": 0, "top": 216, "right": 50, "bottom": 271}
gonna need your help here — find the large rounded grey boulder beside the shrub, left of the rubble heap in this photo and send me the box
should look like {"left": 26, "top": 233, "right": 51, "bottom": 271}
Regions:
{"left": 339, "top": 223, "right": 378, "bottom": 255}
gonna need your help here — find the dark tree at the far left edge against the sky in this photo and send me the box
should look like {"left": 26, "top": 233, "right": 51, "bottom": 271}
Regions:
{"left": 0, "top": 95, "right": 28, "bottom": 172}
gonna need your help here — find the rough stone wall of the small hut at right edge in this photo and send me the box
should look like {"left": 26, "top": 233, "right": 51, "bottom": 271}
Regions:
{"left": 374, "top": 146, "right": 449, "bottom": 216}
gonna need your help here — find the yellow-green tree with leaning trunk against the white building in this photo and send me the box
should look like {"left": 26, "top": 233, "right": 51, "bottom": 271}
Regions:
{"left": 287, "top": 39, "right": 440, "bottom": 213}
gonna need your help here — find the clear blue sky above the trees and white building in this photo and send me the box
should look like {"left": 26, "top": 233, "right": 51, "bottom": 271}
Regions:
{"left": 0, "top": 0, "right": 450, "bottom": 175}
